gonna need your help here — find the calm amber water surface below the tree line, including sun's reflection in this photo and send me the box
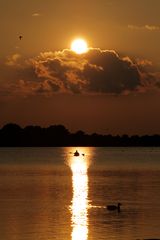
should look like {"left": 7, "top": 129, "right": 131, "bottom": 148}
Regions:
{"left": 0, "top": 148, "right": 160, "bottom": 240}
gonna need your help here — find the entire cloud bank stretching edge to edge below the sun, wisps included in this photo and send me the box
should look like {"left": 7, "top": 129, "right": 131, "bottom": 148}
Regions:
{"left": 0, "top": 48, "right": 160, "bottom": 96}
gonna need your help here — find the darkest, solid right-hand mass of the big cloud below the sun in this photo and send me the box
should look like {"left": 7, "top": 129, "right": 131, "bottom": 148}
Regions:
{"left": 84, "top": 50, "right": 141, "bottom": 94}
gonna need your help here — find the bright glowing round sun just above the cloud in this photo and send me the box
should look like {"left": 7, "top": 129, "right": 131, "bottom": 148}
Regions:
{"left": 71, "top": 38, "right": 88, "bottom": 54}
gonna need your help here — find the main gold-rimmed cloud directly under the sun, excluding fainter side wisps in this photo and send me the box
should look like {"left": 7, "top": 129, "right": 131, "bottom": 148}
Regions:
{"left": 31, "top": 49, "right": 141, "bottom": 94}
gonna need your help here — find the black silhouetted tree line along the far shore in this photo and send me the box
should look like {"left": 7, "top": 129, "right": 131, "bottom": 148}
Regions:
{"left": 0, "top": 123, "right": 160, "bottom": 147}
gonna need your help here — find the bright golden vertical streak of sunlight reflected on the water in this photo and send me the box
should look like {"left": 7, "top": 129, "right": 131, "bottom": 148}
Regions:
{"left": 69, "top": 148, "right": 89, "bottom": 240}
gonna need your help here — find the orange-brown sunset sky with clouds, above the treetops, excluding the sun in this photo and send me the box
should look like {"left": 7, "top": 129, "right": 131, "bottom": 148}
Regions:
{"left": 0, "top": 0, "right": 160, "bottom": 135}
